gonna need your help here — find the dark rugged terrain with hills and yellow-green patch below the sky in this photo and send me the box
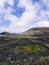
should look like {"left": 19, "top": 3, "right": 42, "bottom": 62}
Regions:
{"left": 0, "top": 28, "right": 49, "bottom": 65}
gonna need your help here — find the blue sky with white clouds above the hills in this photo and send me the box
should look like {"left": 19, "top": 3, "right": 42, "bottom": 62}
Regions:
{"left": 0, "top": 0, "right": 49, "bottom": 33}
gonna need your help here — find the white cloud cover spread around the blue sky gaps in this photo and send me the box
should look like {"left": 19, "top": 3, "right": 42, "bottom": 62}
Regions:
{"left": 0, "top": 0, "right": 49, "bottom": 33}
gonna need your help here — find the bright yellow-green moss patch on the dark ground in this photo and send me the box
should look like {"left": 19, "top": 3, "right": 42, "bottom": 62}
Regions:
{"left": 16, "top": 45, "right": 41, "bottom": 54}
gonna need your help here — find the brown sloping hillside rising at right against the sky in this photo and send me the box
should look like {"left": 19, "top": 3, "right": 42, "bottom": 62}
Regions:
{"left": 21, "top": 27, "right": 49, "bottom": 35}
